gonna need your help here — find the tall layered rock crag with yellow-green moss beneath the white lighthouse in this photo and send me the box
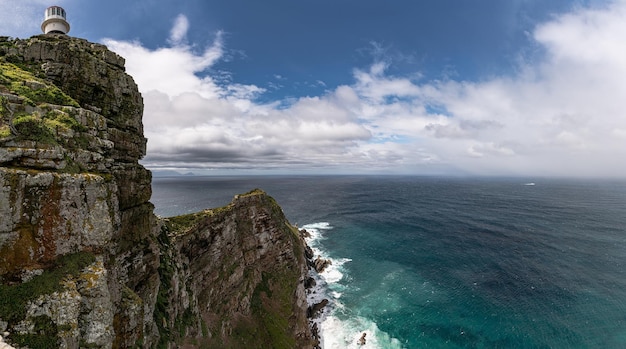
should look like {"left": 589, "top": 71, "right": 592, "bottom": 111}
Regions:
{"left": 0, "top": 35, "right": 159, "bottom": 348}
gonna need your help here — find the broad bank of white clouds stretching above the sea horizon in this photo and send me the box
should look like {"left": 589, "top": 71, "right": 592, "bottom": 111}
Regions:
{"left": 105, "top": 1, "right": 626, "bottom": 176}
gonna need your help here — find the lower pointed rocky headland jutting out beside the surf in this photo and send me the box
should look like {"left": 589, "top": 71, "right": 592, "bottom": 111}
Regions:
{"left": 157, "top": 190, "right": 312, "bottom": 348}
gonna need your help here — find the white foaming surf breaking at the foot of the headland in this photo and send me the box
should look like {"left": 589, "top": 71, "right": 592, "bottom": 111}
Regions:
{"left": 302, "top": 222, "right": 402, "bottom": 349}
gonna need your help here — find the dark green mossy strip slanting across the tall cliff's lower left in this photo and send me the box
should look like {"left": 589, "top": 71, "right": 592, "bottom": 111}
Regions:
{"left": 0, "top": 252, "right": 95, "bottom": 326}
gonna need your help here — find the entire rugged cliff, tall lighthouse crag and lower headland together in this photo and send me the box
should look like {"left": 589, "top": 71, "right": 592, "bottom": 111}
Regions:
{"left": 0, "top": 35, "right": 311, "bottom": 348}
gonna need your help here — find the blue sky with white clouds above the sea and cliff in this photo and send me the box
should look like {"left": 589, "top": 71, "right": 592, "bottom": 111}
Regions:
{"left": 0, "top": 0, "right": 626, "bottom": 178}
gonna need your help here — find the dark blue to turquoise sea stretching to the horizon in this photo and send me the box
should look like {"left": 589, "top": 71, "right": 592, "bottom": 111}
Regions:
{"left": 152, "top": 176, "right": 626, "bottom": 349}
